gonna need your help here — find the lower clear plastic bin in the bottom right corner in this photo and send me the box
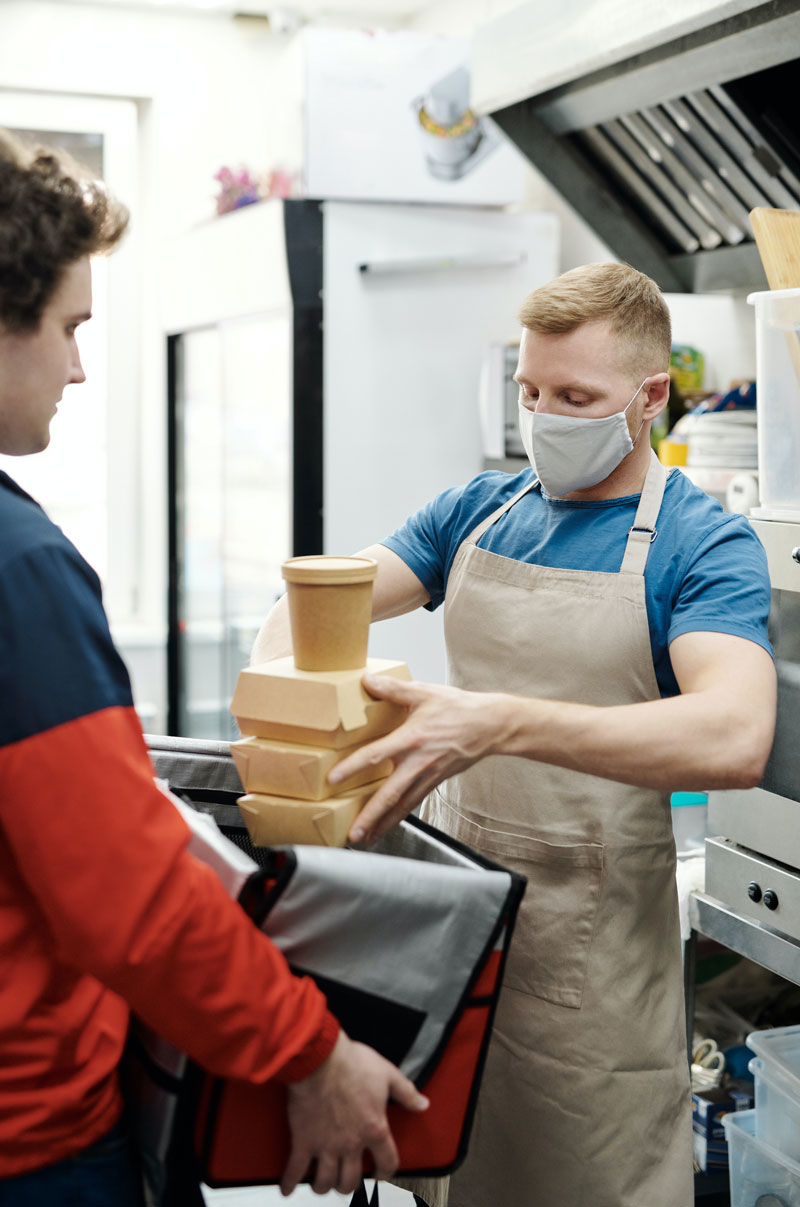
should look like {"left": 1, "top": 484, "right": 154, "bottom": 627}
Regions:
{"left": 723, "top": 1110, "right": 800, "bottom": 1207}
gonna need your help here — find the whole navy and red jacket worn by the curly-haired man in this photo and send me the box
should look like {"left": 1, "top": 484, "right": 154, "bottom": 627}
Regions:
{"left": 0, "top": 472, "right": 339, "bottom": 1179}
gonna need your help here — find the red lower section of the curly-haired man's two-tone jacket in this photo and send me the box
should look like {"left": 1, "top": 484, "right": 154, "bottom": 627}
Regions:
{"left": 0, "top": 709, "right": 338, "bottom": 1178}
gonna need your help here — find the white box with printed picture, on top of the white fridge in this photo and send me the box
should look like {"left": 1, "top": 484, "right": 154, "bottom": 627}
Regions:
{"left": 303, "top": 29, "right": 525, "bottom": 205}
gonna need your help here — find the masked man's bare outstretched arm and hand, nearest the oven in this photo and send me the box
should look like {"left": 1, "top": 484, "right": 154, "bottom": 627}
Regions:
{"left": 329, "top": 632, "right": 776, "bottom": 841}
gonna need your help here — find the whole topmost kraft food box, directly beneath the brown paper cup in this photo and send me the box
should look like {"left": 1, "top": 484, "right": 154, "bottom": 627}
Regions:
{"left": 230, "top": 655, "right": 411, "bottom": 750}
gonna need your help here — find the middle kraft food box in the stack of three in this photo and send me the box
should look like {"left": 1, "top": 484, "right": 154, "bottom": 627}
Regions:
{"left": 230, "top": 737, "right": 392, "bottom": 800}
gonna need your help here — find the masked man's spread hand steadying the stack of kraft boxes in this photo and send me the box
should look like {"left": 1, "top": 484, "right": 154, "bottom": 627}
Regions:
{"left": 328, "top": 675, "right": 509, "bottom": 842}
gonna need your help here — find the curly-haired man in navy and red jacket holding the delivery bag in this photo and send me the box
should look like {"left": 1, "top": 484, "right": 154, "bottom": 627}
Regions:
{"left": 0, "top": 132, "right": 426, "bottom": 1207}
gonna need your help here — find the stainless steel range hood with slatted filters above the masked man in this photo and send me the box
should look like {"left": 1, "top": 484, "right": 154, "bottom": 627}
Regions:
{"left": 473, "top": 0, "right": 800, "bottom": 292}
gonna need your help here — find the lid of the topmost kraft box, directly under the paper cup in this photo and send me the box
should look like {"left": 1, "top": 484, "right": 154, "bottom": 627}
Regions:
{"left": 230, "top": 655, "right": 411, "bottom": 730}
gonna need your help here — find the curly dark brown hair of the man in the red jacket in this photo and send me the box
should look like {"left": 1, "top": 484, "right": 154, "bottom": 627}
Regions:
{"left": 0, "top": 129, "right": 128, "bottom": 332}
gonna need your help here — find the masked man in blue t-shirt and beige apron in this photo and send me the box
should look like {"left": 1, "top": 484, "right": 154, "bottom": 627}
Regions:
{"left": 253, "top": 264, "right": 776, "bottom": 1207}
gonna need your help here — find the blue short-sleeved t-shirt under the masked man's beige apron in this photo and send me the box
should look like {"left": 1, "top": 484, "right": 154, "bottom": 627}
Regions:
{"left": 383, "top": 468, "right": 772, "bottom": 696}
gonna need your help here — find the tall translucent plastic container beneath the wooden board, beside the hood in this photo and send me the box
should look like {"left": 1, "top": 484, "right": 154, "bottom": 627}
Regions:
{"left": 747, "top": 290, "right": 800, "bottom": 520}
